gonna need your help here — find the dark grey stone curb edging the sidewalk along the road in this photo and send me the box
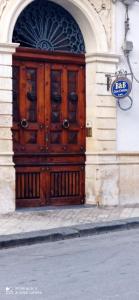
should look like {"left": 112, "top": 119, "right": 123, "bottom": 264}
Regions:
{"left": 0, "top": 218, "right": 139, "bottom": 249}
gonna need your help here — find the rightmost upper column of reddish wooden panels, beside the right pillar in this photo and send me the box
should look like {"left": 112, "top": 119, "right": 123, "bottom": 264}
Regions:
{"left": 67, "top": 66, "right": 85, "bottom": 153}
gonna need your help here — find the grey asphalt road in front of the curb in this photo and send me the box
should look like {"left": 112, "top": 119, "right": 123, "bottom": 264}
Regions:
{"left": 0, "top": 229, "right": 139, "bottom": 300}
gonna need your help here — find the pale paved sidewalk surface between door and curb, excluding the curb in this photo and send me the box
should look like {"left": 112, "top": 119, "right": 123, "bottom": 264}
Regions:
{"left": 0, "top": 205, "right": 139, "bottom": 236}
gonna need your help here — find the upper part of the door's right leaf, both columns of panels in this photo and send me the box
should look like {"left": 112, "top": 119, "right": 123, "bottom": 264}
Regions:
{"left": 47, "top": 64, "right": 85, "bottom": 153}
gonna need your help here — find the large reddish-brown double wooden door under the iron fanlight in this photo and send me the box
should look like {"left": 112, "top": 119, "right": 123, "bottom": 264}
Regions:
{"left": 12, "top": 49, "right": 85, "bottom": 207}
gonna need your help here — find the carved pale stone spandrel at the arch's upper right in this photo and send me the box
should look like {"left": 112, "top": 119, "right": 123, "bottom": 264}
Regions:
{"left": 88, "top": 0, "right": 112, "bottom": 47}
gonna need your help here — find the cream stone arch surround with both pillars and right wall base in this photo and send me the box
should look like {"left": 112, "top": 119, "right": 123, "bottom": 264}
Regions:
{"left": 0, "top": 0, "right": 139, "bottom": 212}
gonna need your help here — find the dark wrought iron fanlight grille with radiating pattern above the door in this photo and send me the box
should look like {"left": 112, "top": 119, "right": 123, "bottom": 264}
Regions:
{"left": 13, "top": 0, "right": 85, "bottom": 53}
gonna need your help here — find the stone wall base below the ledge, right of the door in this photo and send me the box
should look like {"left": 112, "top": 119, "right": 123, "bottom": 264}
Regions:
{"left": 86, "top": 152, "right": 139, "bottom": 205}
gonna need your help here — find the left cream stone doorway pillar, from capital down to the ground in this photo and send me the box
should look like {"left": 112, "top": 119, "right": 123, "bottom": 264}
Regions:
{"left": 0, "top": 44, "right": 18, "bottom": 212}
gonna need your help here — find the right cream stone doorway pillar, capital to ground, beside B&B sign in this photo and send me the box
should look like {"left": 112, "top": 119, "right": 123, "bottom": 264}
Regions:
{"left": 86, "top": 54, "right": 119, "bottom": 205}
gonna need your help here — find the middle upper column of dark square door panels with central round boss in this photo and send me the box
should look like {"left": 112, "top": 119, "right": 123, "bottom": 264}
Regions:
{"left": 46, "top": 64, "right": 65, "bottom": 153}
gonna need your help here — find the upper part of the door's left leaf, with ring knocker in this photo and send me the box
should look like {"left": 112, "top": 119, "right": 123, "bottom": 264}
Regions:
{"left": 13, "top": 62, "right": 44, "bottom": 153}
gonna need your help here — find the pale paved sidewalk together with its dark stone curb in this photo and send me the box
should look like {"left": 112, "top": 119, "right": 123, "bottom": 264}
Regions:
{"left": 0, "top": 205, "right": 139, "bottom": 247}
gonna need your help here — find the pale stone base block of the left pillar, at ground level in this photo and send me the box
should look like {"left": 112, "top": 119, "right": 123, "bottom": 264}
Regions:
{"left": 0, "top": 166, "right": 15, "bottom": 213}
